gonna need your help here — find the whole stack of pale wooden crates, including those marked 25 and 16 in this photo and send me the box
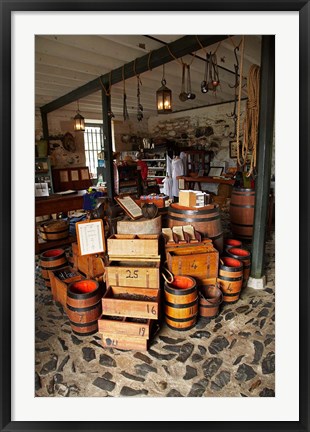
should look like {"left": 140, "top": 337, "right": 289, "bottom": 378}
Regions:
{"left": 98, "top": 234, "right": 160, "bottom": 351}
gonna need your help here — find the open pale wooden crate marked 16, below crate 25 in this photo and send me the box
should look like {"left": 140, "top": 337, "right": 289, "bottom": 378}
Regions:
{"left": 102, "top": 286, "right": 160, "bottom": 319}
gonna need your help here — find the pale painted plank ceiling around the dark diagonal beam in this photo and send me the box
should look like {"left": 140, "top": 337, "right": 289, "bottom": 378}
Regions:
{"left": 35, "top": 35, "right": 261, "bottom": 119}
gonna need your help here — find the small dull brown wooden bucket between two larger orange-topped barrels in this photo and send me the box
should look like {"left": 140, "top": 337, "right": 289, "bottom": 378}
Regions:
{"left": 199, "top": 285, "right": 223, "bottom": 318}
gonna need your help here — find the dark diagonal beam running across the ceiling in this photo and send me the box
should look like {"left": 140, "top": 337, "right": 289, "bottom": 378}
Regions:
{"left": 40, "top": 35, "right": 227, "bottom": 114}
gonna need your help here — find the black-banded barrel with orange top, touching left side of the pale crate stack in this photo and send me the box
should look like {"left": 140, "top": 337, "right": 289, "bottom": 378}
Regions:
{"left": 66, "top": 279, "right": 103, "bottom": 336}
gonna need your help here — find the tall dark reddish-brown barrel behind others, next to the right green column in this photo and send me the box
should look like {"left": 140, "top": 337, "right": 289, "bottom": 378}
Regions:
{"left": 229, "top": 188, "right": 255, "bottom": 240}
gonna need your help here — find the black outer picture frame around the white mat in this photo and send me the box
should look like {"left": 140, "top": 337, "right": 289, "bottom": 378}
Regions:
{"left": 0, "top": 0, "right": 310, "bottom": 432}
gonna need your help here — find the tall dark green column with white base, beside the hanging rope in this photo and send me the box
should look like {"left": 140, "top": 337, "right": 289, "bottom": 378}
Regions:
{"left": 248, "top": 36, "right": 275, "bottom": 288}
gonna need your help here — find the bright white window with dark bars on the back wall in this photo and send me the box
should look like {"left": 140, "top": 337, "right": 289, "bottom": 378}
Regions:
{"left": 84, "top": 123, "right": 105, "bottom": 178}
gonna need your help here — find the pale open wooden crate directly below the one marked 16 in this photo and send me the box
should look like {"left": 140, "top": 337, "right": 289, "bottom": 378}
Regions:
{"left": 98, "top": 315, "right": 153, "bottom": 339}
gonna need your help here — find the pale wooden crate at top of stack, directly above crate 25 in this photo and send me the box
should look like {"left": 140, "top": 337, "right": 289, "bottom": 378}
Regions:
{"left": 107, "top": 234, "right": 159, "bottom": 260}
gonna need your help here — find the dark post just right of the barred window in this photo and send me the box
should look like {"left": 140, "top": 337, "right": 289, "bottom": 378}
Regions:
{"left": 101, "top": 90, "right": 115, "bottom": 198}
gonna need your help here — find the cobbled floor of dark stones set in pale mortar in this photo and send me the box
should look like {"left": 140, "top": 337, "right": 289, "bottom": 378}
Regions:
{"left": 35, "top": 213, "right": 275, "bottom": 397}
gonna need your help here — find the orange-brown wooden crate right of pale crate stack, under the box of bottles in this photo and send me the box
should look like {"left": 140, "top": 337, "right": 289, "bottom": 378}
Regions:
{"left": 166, "top": 244, "right": 219, "bottom": 285}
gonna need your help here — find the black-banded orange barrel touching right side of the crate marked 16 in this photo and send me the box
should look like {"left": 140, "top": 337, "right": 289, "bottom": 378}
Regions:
{"left": 164, "top": 276, "right": 198, "bottom": 331}
